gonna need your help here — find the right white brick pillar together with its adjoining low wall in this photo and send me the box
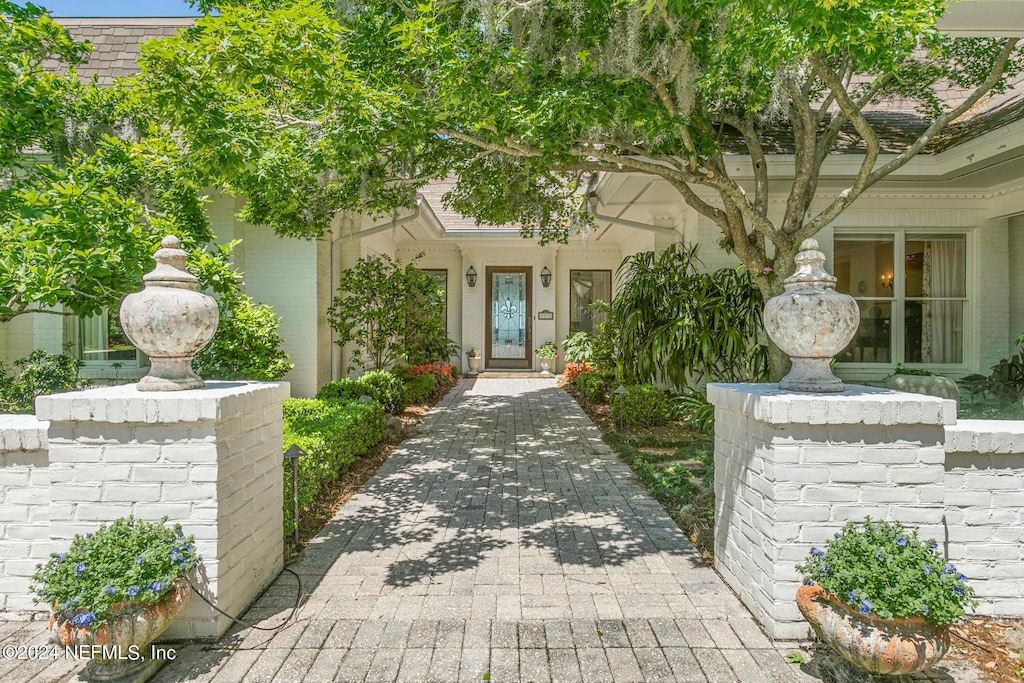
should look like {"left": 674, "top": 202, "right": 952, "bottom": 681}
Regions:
{"left": 709, "top": 384, "right": 1024, "bottom": 639}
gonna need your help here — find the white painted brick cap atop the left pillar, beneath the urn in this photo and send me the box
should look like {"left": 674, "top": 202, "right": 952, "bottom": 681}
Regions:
{"left": 36, "top": 381, "right": 290, "bottom": 424}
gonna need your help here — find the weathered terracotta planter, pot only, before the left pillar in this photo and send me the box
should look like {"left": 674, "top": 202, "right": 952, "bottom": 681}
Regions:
{"left": 50, "top": 581, "right": 191, "bottom": 681}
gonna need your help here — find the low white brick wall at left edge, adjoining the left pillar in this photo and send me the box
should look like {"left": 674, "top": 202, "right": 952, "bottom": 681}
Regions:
{"left": 0, "top": 415, "right": 51, "bottom": 620}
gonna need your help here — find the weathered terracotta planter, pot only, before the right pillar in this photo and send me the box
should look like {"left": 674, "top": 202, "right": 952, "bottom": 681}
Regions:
{"left": 797, "top": 586, "right": 949, "bottom": 675}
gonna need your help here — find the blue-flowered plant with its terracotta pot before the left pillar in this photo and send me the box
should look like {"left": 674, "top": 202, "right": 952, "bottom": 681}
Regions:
{"left": 32, "top": 517, "right": 200, "bottom": 681}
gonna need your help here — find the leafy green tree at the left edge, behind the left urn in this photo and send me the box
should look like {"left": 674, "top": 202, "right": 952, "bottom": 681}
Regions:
{"left": 0, "top": 0, "right": 220, "bottom": 323}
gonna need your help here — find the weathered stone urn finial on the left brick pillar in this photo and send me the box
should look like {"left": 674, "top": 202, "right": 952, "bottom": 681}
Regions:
{"left": 121, "top": 236, "right": 219, "bottom": 391}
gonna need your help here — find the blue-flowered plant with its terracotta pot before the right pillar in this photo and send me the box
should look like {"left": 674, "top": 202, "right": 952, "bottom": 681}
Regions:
{"left": 797, "top": 517, "right": 977, "bottom": 674}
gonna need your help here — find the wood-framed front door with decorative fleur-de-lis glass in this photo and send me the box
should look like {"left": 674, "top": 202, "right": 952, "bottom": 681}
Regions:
{"left": 486, "top": 266, "right": 534, "bottom": 369}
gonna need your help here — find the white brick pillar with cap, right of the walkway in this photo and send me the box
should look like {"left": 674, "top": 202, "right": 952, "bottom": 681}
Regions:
{"left": 708, "top": 384, "right": 956, "bottom": 640}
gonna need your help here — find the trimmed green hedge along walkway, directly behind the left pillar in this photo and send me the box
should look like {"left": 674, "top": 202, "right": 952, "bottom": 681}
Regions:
{"left": 284, "top": 398, "right": 384, "bottom": 533}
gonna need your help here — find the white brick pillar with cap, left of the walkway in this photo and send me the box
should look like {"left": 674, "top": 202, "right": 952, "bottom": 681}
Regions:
{"left": 36, "top": 382, "right": 289, "bottom": 639}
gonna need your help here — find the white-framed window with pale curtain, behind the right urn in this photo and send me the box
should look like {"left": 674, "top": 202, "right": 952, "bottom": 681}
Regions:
{"left": 835, "top": 230, "right": 969, "bottom": 365}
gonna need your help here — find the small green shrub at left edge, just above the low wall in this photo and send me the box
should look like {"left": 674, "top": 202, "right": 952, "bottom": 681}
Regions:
{"left": 0, "top": 348, "right": 89, "bottom": 413}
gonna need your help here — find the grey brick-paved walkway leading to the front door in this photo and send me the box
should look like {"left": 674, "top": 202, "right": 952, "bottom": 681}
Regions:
{"left": 0, "top": 379, "right": 974, "bottom": 683}
